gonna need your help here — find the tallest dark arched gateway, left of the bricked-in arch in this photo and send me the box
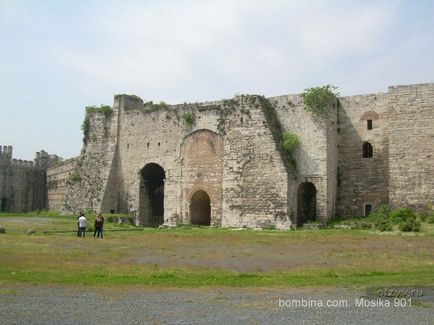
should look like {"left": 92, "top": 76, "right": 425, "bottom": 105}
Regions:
{"left": 139, "top": 163, "right": 166, "bottom": 227}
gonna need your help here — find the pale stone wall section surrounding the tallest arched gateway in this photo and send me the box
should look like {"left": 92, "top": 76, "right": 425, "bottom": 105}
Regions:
{"left": 115, "top": 95, "right": 186, "bottom": 222}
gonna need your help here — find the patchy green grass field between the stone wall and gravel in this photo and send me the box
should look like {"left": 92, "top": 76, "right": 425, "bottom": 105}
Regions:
{"left": 0, "top": 213, "right": 434, "bottom": 287}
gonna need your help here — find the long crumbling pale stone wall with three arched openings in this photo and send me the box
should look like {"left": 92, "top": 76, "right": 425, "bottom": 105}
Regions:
{"left": 45, "top": 84, "right": 434, "bottom": 228}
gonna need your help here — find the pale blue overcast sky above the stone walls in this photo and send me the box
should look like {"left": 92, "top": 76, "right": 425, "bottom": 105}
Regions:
{"left": 0, "top": 0, "right": 434, "bottom": 160}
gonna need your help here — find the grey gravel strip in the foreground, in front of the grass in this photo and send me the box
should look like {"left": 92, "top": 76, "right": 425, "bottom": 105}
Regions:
{"left": 0, "top": 285, "right": 434, "bottom": 324}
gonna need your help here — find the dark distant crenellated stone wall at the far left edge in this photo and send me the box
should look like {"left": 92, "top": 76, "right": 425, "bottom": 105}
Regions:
{"left": 0, "top": 146, "right": 59, "bottom": 212}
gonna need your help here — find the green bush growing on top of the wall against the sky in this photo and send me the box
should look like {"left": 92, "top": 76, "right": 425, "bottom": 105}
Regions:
{"left": 301, "top": 85, "right": 339, "bottom": 115}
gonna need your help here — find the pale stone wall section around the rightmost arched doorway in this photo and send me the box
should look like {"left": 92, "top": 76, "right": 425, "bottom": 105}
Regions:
{"left": 270, "top": 95, "right": 337, "bottom": 222}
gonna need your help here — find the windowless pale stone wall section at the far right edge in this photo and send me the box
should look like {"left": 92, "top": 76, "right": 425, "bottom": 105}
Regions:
{"left": 389, "top": 83, "right": 434, "bottom": 210}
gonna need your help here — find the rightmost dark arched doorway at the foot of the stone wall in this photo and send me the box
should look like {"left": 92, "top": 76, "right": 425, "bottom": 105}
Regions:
{"left": 297, "top": 182, "right": 316, "bottom": 226}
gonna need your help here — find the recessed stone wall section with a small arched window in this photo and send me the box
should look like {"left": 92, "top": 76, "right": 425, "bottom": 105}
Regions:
{"left": 337, "top": 93, "right": 389, "bottom": 216}
